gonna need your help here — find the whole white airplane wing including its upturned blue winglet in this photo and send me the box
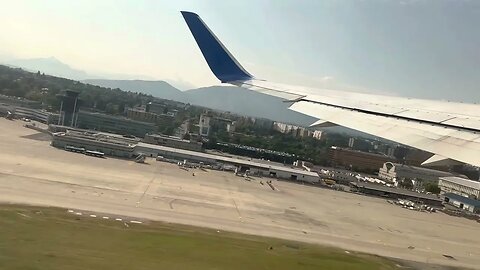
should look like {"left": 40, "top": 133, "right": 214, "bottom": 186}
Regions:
{"left": 182, "top": 11, "right": 480, "bottom": 166}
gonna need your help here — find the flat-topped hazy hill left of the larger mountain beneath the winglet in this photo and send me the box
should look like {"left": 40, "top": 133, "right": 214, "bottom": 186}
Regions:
{"left": 82, "top": 79, "right": 184, "bottom": 102}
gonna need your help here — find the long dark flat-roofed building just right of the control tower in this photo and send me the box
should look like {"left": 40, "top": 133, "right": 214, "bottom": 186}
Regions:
{"left": 76, "top": 111, "right": 156, "bottom": 138}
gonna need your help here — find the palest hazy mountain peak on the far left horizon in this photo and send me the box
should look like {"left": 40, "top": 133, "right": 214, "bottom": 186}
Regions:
{"left": 5, "top": 57, "right": 92, "bottom": 80}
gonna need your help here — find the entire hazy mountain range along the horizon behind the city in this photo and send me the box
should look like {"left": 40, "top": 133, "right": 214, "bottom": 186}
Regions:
{"left": 3, "top": 57, "right": 366, "bottom": 131}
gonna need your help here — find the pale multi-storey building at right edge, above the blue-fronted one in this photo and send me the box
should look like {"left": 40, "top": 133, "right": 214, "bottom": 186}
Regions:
{"left": 438, "top": 177, "right": 480, "bottom": 200}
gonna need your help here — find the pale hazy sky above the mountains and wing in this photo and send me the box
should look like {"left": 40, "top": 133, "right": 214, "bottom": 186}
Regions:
{"left": 0, "top": 0, "right": 480, "bottom": 103}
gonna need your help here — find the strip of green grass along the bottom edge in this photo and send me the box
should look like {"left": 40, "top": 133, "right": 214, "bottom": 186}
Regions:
{"left": 0, "top": 205, "right": 395, "bottom": 270}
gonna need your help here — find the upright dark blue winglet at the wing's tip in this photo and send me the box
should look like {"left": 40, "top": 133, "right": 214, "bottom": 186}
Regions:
{"left": 181, "top": 11, "right": 253, "bottom": 83}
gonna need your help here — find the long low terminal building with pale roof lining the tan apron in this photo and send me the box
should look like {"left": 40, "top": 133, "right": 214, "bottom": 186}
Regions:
{"left": 51, "top": 130, "right": 320, "bottom": 183}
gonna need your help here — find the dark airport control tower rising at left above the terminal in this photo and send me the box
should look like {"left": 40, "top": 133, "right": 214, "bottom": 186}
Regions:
{"left": 57, "top": 90, "right": 80, "bottom": 127}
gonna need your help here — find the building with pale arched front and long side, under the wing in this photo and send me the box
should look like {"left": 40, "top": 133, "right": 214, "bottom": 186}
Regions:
{"left": 378, "top": 162, "right": 454, "bottom": 185}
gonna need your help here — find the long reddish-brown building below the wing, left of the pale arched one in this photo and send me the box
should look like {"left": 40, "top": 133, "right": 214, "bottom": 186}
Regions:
{"left": 328, "top": 146, "right": 393, "bottom": 171}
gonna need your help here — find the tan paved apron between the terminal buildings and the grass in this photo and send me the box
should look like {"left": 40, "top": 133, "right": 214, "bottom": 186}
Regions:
{"left": 0, "top": 119, "right": 480, "bottom": 268}
